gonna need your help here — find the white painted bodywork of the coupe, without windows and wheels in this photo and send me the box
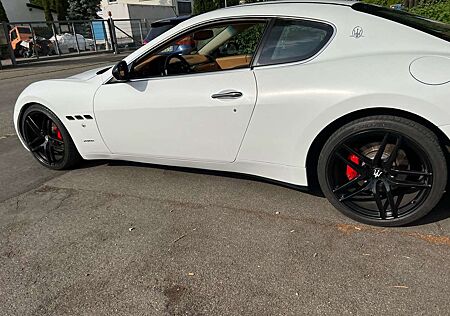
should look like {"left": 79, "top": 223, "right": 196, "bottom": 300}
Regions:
{"left": 14, "top": 1, "right": 450, "bottom": 185}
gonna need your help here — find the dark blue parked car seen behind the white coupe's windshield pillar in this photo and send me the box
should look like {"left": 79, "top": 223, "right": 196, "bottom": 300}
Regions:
{"left": 144, "top": 16, "right": 196, "bottom": 53}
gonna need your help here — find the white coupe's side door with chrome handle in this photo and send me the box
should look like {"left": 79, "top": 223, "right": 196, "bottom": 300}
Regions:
{"left": 94, "top": 22, "right": 262, "bottom": 162}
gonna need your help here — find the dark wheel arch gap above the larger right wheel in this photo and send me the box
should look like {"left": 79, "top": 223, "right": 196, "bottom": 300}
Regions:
{"left": 306, "top": 107, "right": 450, "bottom": 193}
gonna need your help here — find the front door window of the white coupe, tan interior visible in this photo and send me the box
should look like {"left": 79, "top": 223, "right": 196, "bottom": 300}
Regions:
{"left": 130, "top": 20, "right": 267, "bottom": 79}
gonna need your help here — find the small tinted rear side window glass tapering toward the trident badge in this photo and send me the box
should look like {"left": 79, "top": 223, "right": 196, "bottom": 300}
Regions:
{"left": 258, "top": 20, "right": 333, "bottom": 65}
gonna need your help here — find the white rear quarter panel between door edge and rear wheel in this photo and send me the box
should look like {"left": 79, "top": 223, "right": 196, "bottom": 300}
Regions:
{"left": 238, "top": 7, "right": 450, "bottom": 173}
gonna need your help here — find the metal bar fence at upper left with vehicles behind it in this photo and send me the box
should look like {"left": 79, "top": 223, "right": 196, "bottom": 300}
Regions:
{"left": 0, "top": 18, "right": 150, "bottom": 68}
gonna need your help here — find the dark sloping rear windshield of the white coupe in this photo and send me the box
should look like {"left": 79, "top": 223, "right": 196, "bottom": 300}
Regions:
{"left": 352, "top": 3, "right": 450, "bottom": 42}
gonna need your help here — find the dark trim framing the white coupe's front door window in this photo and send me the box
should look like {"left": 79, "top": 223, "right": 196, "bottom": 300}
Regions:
{"left": 110, "top": 16, "right": 274, "bottom": 84}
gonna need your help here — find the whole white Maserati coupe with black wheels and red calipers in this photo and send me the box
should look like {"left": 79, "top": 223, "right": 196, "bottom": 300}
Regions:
{"left": 14, "top": 1, "right": 450, "bottom": 226}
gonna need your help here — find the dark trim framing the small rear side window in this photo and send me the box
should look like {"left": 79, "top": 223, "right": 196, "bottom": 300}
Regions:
{"left": 252, "top": 16, "right": 337, "bottom": 69}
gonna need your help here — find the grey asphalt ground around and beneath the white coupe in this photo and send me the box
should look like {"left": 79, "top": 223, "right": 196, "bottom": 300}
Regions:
{"left": 0, "top": 56, "right": 450, "bottom": 315}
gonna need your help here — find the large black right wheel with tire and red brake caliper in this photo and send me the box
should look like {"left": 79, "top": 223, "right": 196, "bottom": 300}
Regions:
{"left": 317, "top": 115, "right": 447, "bottom": 226}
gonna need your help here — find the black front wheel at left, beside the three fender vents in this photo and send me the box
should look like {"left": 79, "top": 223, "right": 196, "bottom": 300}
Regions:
{"left": 20, "top": 104, "right": 81, "bottom": 170}
